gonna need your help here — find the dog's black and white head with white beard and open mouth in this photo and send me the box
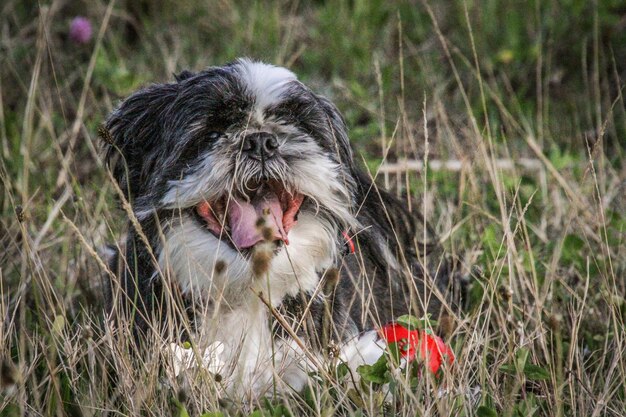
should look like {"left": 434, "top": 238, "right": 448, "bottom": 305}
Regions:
{"left": 106, "top": 60, "right": 356, "bottom": 299}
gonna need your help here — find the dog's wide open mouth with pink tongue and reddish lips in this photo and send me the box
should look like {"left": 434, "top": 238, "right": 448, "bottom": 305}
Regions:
{"left": 196, "top": 181, "right": 304, "bottom": 249}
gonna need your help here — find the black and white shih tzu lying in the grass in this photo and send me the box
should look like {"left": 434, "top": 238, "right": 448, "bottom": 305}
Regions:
{"left": 103, "top": 59, "right": 458, "bottom": 394}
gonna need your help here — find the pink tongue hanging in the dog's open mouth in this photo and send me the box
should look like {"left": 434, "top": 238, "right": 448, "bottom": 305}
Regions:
{"left": 228, "top": 193, "right": 289, "bottom": 249}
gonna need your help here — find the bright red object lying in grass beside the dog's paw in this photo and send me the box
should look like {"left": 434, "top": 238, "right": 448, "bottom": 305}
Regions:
{"left": 380, "top": 323, "right": 454, "bottom": 374}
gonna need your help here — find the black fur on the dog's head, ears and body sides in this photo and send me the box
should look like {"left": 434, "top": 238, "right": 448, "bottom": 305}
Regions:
{"left": 105, "top": 58, "right": 460, "bottom": 348}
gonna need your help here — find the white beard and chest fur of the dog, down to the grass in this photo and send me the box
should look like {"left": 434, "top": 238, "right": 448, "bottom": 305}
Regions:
{"left": 159, "top": 213, "right": 336, "bottom": 393}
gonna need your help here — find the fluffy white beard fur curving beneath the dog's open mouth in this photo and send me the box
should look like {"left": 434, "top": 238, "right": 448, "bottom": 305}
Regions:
{"left": 159, "top": 214, "right": 337, "bottom": 304}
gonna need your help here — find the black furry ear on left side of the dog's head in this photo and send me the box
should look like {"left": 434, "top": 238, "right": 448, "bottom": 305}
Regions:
{"left": 99, "top": 83, "right": 178, "bottom": 199}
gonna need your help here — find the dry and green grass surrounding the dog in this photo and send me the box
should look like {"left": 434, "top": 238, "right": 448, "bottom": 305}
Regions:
{"left": 0, "top": 0, "right": 626, "bottom": 416}
